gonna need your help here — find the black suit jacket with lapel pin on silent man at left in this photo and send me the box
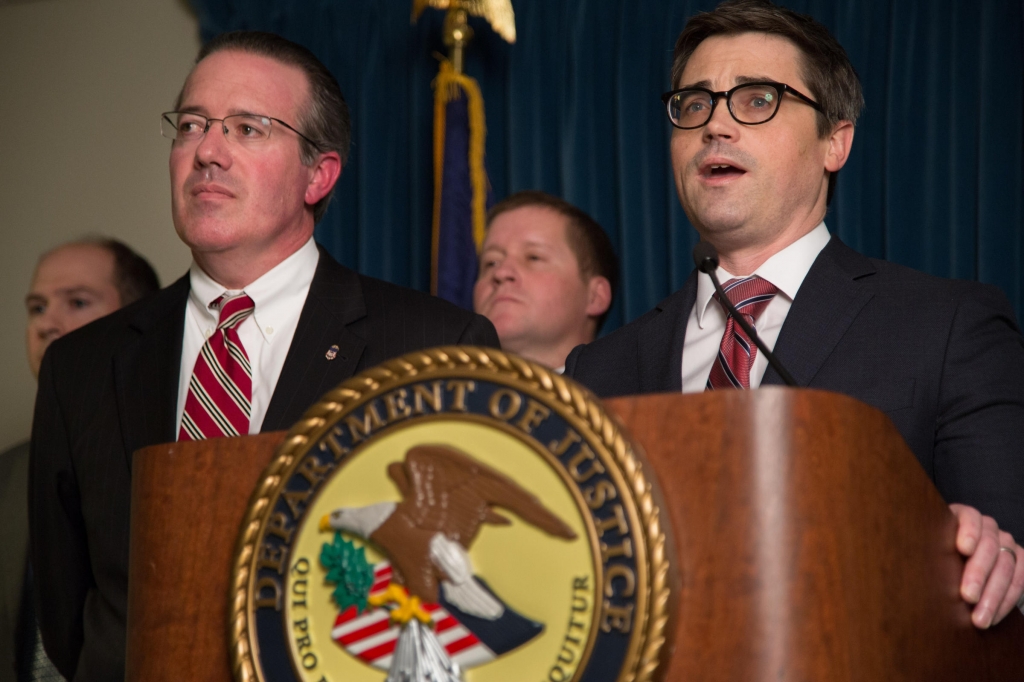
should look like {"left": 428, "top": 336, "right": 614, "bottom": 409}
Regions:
{"left": 30, "top": 250, "right": 498, "bottom": 682}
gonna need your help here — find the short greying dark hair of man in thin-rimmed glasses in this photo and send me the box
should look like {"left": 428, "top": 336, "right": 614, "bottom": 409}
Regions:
{"left": 174, "top": 31, "right": 352, "bottom": 222}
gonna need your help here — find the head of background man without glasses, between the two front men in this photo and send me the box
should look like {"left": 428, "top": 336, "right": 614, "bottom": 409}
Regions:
{"left": 473, "top": 190, "right": 618, "bottom": 372}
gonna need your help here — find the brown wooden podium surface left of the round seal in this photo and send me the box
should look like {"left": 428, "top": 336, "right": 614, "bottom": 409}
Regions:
{"left": 125, "top": 431, "right": 285, "bottom": 682}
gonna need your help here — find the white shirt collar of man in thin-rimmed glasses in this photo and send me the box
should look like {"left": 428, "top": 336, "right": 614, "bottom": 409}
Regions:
{"left": 188, "top": 237, "right": 319, "bottom": 343}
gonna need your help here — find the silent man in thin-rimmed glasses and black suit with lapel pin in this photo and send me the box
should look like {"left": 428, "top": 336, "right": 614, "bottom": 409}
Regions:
{"left": 30, "top": 33, "right": 498, "bottom": 682}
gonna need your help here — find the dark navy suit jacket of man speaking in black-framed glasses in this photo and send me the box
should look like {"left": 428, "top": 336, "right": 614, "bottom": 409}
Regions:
{"left": 565, "top": 236, "right": 1024, "bottom": 540}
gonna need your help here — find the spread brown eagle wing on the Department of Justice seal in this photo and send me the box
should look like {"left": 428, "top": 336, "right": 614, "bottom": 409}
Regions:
{"left": 389, "top": 445, "right": 575, "bottom": 548}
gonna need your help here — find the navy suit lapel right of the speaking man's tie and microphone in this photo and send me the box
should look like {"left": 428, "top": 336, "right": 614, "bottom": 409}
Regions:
{"left": 761, "top": 235, "right": 876, "bottom": 386}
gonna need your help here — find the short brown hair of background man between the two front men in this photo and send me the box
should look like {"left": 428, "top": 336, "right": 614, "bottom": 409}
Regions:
{"left": 486, "top": 189, "right": 618, "bottom": 331}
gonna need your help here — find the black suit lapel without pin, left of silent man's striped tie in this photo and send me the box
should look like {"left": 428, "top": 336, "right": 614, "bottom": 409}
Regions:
{"left": 114, "top": 274, "right": 188, "bottom": 468}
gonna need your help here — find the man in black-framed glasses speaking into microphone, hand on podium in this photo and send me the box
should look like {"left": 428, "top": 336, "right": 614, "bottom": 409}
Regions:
{"left": 566, "top": 0, "right": 1024, "bottom": 628}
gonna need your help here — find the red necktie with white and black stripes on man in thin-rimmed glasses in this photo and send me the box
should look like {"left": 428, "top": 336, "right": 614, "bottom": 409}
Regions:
{"left": 178, "top": 294, "right": 256, "bottom": 440}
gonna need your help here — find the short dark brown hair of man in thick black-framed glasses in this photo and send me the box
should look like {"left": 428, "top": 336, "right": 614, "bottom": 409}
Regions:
{"left": 672, "top": 0, "right": 864, "bottom": 201}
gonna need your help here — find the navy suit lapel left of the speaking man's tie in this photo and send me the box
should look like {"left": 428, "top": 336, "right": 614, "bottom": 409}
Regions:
{"left": 637, "top": 270, "right": 697, "bottom": 393}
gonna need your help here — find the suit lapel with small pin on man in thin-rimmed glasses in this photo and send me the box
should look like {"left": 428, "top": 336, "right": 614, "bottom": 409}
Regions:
{"left": 260, "top": 248, "right": 367, "bottom": 432}
